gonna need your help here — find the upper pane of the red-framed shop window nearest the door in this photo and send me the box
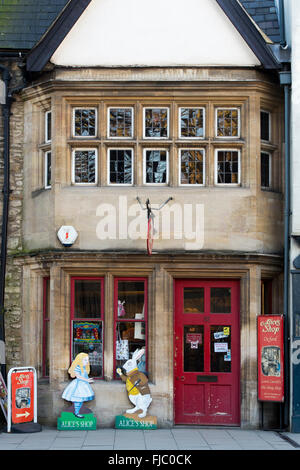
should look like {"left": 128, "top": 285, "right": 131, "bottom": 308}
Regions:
{"left": 118, "top": 281, "right": 145, "bottom": 320}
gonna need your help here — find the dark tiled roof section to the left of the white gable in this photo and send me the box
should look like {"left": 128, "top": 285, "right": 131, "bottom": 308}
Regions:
{"left": 0, "top": 0, "right": 68, "bottom": 50}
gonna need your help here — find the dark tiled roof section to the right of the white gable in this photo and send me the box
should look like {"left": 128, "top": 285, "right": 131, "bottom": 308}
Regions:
{"left": 240, "top": 0, "right": 280, "bottom": 43}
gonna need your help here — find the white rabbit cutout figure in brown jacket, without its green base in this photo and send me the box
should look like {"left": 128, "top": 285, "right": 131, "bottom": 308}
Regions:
{"left": 117, "top": 349, "right": 152, "bottom": 418}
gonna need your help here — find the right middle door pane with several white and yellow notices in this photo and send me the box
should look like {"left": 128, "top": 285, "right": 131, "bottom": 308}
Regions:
{"left": 210, "top": 325, "right": 231, "bottom": 372}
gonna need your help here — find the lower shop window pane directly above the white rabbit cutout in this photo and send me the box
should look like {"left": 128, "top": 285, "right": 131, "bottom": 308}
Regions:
{"left": 115, "top": 321, "right": 146, "bottom": 370}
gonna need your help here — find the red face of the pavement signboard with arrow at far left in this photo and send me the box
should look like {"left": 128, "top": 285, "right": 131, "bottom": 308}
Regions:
{"left": 11, "top": 370, "right": 35, "bottom": 424}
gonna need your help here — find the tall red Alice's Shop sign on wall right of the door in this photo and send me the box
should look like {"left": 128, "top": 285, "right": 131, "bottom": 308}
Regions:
{"left": 257, "top": 315, "right": 284, "bottom": 402}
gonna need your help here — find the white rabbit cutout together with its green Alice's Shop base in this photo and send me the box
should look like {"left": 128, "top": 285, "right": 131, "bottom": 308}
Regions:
{"left": 116, "top": 349, "right": 157, "bottom": 429}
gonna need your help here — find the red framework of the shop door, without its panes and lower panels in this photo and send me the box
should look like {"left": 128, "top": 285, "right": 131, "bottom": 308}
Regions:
{"left": 174, "top": 279, "right": 240, "bottom": 426}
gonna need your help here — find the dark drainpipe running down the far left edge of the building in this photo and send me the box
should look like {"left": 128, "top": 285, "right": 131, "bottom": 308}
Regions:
{"left": 0, "top": 64, "right": 11, "bottom": 380}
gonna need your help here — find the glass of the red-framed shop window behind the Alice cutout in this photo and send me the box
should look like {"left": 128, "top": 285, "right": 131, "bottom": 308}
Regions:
{"left": 71, "top": 278, "right": 104, "bottom": 378}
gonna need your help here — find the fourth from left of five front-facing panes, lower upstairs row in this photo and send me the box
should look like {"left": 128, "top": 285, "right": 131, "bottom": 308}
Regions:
{"left": 180, "top": 149, "right": 204, "bottom": 184}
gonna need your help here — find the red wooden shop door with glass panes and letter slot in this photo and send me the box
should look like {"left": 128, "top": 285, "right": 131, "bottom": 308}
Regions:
{"left": 174, "top": 280, "right": 240, "bottom": 426}
